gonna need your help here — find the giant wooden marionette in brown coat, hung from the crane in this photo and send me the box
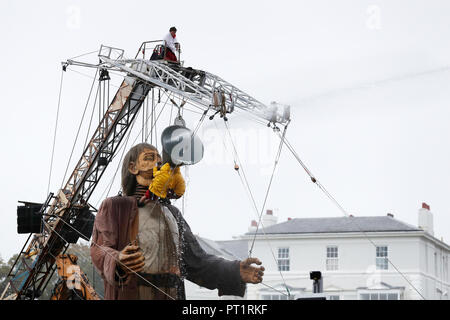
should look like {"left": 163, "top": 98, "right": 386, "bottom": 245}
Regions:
{"left": 91, "top": 125, "right": 264, "bottom": 300}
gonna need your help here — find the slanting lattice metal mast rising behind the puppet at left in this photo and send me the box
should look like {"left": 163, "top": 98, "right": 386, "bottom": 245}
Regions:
{"left": 2, "top": 56, "right": 153, "bottom": 299}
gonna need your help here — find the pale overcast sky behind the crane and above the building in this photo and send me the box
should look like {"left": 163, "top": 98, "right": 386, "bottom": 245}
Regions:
{"left": 0, "top": 0, "right": 450, "bottom": 270}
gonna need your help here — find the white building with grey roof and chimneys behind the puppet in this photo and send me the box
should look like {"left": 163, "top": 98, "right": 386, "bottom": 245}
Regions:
{"left": 186, "top": 203, "right": 450, "bottom": 300}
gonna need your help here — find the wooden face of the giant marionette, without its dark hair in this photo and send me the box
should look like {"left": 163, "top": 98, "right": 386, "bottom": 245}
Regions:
{"left": 128, "top": 148, "right": 161, "bottom": 187}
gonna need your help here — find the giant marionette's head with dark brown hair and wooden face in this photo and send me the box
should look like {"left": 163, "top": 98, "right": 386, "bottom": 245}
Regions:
{"left": 122, "top": 143, "right": 161, "bottom": 196}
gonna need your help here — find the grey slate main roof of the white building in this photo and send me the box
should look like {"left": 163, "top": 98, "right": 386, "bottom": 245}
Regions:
{"left": 246, "top": 216, "right": 422, "bottom": 235}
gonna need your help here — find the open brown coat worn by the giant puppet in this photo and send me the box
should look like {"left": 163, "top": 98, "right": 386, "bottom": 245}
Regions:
{"left": 91, "top": 197, "right": 246, "bottom": 300}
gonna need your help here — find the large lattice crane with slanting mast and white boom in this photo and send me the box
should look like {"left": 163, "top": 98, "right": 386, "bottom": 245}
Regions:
{"left": 0, "top": 41, "right": 290, "bottom": 300}
